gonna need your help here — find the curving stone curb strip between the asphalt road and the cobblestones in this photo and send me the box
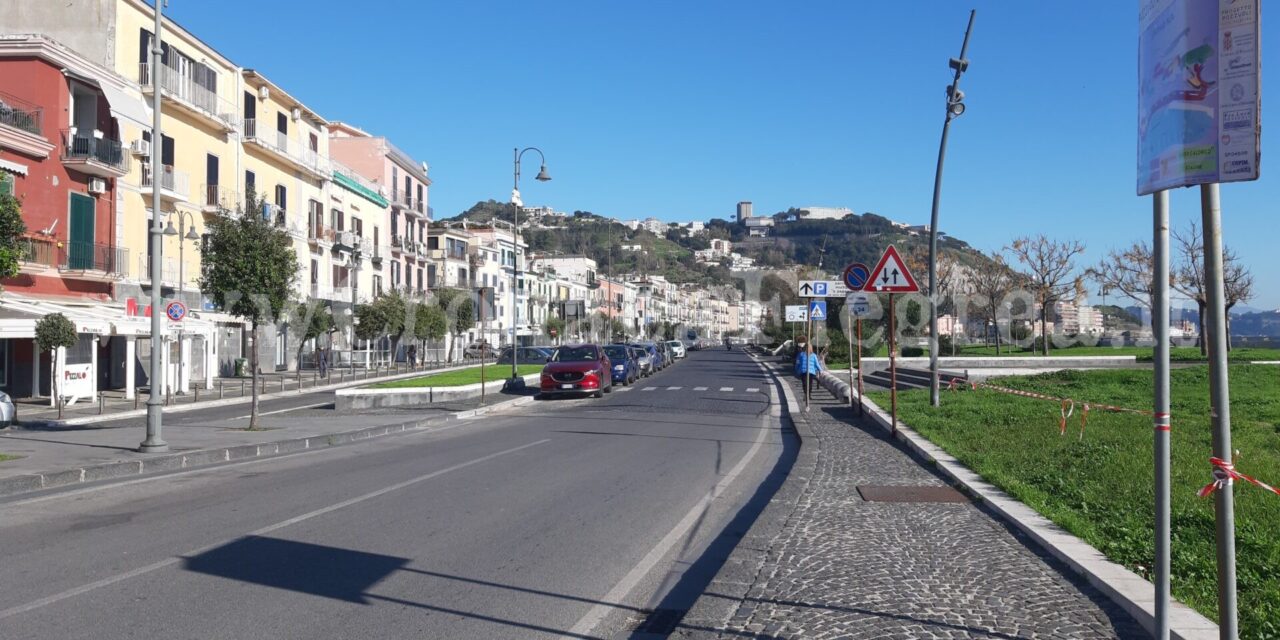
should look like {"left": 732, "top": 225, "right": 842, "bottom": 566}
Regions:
{"left": 672, "top": 352, "right": 819, "bottom": 640}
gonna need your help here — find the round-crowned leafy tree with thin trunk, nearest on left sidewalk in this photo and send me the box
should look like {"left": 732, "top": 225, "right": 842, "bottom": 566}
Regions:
{"left": 200, "top": 191, "right": 298, "bottom": 429}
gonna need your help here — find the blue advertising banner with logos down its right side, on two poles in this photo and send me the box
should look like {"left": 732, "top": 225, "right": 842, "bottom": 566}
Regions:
{"left": 1138, "top": 0, "right": 1262, "bottom": 196}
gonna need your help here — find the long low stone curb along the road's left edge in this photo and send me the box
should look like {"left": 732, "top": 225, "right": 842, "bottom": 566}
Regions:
{"left": 0, "top": 396, "right": 534, "bottom": 498}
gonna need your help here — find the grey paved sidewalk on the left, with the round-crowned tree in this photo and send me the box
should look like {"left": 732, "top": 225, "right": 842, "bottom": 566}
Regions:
{"left": 0, "top": 358, "right": 522, "bottom": 497}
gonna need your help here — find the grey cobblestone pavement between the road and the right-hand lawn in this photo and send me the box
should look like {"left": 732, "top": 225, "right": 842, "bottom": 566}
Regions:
{"left": 677, "top": 373, "right": 1146, "bottom": 639}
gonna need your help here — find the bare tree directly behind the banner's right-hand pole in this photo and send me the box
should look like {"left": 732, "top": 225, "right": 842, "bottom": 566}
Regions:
{"left": 1171, "top": 223, "right": 1253, "bottom": 356}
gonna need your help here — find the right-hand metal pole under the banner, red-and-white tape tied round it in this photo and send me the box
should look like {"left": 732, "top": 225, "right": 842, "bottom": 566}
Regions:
{"left": 1201, "top": 184, "right": 1239, "bottom": 640}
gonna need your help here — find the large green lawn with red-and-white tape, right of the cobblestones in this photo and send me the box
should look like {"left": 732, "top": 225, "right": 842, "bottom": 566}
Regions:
{"left": 868, "top": 365, "right": 1280, "bottom": 637}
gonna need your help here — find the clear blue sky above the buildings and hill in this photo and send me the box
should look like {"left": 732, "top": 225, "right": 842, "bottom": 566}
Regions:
{"left": 168, "top": 0, "right": 1280, "bottom": 308}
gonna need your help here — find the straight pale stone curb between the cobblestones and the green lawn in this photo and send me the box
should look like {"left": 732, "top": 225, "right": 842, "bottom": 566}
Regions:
{"left": 863, "top": 398, "right": 1219, "bottom": 640}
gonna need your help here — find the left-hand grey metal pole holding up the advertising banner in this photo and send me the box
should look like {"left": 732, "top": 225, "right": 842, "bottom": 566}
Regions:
{"left": 1151, "top": 191, "right": 1170, "bottom": 640}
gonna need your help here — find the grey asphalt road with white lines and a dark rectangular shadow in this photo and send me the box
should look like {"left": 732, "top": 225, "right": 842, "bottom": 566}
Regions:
{"left": 0, "top": 351, "right": 796, "bottom": 639}
